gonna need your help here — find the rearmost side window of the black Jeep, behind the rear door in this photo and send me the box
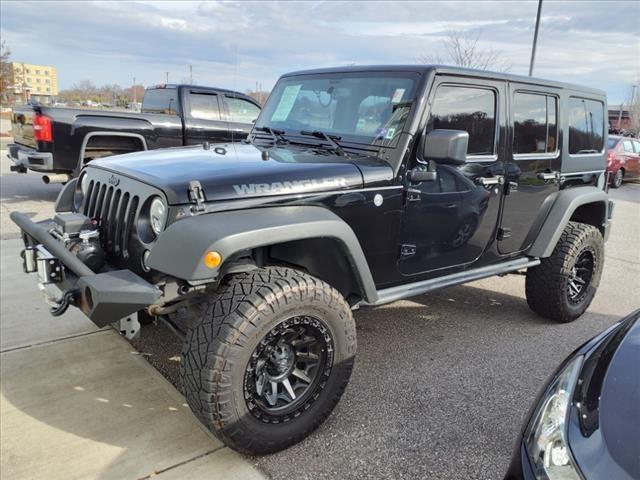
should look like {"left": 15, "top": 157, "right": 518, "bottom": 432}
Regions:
{"left": 569, "top": 97, "right": 604, "bottom": 154}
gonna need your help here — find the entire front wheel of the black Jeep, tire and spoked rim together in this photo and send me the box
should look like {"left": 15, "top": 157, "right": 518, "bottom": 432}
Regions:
{"left": 180, "top": 267, "right": 356, "bottom": 454}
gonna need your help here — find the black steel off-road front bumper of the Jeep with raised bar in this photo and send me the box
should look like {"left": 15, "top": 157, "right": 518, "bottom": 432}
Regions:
{"left": 11, "top": 212, "right": 161, "bottom": 327}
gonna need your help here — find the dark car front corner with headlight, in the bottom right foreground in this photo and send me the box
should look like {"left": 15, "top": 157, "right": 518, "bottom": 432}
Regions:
{"left": 505, "top": 310, "right": 640, "bottom": 480}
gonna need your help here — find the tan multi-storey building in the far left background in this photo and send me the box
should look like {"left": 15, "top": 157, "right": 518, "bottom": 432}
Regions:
{"left": 9, "top": 62, "right": 58, "bottom": 104}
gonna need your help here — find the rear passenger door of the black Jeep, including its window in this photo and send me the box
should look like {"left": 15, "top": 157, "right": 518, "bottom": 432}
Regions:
{"left": 498, "top": 83, "right": 560, "bottom": 254}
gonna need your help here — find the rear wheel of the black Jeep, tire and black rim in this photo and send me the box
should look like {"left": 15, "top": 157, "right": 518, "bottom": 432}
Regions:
{"left": 525, "top": 222, "right": 604, "bottom": 322}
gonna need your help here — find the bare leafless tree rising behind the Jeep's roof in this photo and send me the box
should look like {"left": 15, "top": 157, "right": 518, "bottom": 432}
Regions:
{"left": 418, "top": 30, "right": 511, "bottom": 72}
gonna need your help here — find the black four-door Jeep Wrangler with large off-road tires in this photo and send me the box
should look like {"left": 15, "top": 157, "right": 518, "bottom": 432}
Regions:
{"left": 12, "top": 66, "right": 613, "bottom": 454}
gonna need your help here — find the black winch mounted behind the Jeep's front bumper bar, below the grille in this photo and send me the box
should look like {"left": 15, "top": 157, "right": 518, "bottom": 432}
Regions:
{"left": 50, "top": 212, "right": 105, "bottom": 272}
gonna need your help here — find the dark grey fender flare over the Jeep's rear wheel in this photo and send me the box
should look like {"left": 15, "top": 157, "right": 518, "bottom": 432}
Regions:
{"left": 526, "top": 187, "right": 609, "bottom": 258}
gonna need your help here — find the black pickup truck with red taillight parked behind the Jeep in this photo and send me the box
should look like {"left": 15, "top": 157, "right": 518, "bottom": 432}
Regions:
{"left": 8, "top": 85, "right": 261, "bottom": 183}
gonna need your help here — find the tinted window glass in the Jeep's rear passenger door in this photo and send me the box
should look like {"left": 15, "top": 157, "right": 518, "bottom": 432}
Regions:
{"left": 513, "top": 93, "right": 558, "bottom": 154}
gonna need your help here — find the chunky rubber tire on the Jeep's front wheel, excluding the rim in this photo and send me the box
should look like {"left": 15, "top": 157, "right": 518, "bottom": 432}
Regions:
{"left": 180, "top": 267, "right": 356, "bottom": 455}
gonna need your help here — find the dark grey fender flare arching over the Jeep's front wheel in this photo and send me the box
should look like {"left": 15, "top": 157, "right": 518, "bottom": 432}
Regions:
{"left": 147, "top": 206, "right": 378, "bottom": 303}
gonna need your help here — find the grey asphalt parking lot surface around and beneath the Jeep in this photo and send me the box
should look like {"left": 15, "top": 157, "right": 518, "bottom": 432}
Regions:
{"left": 1, "top": 147, "right": 640, "bottom": 480}
